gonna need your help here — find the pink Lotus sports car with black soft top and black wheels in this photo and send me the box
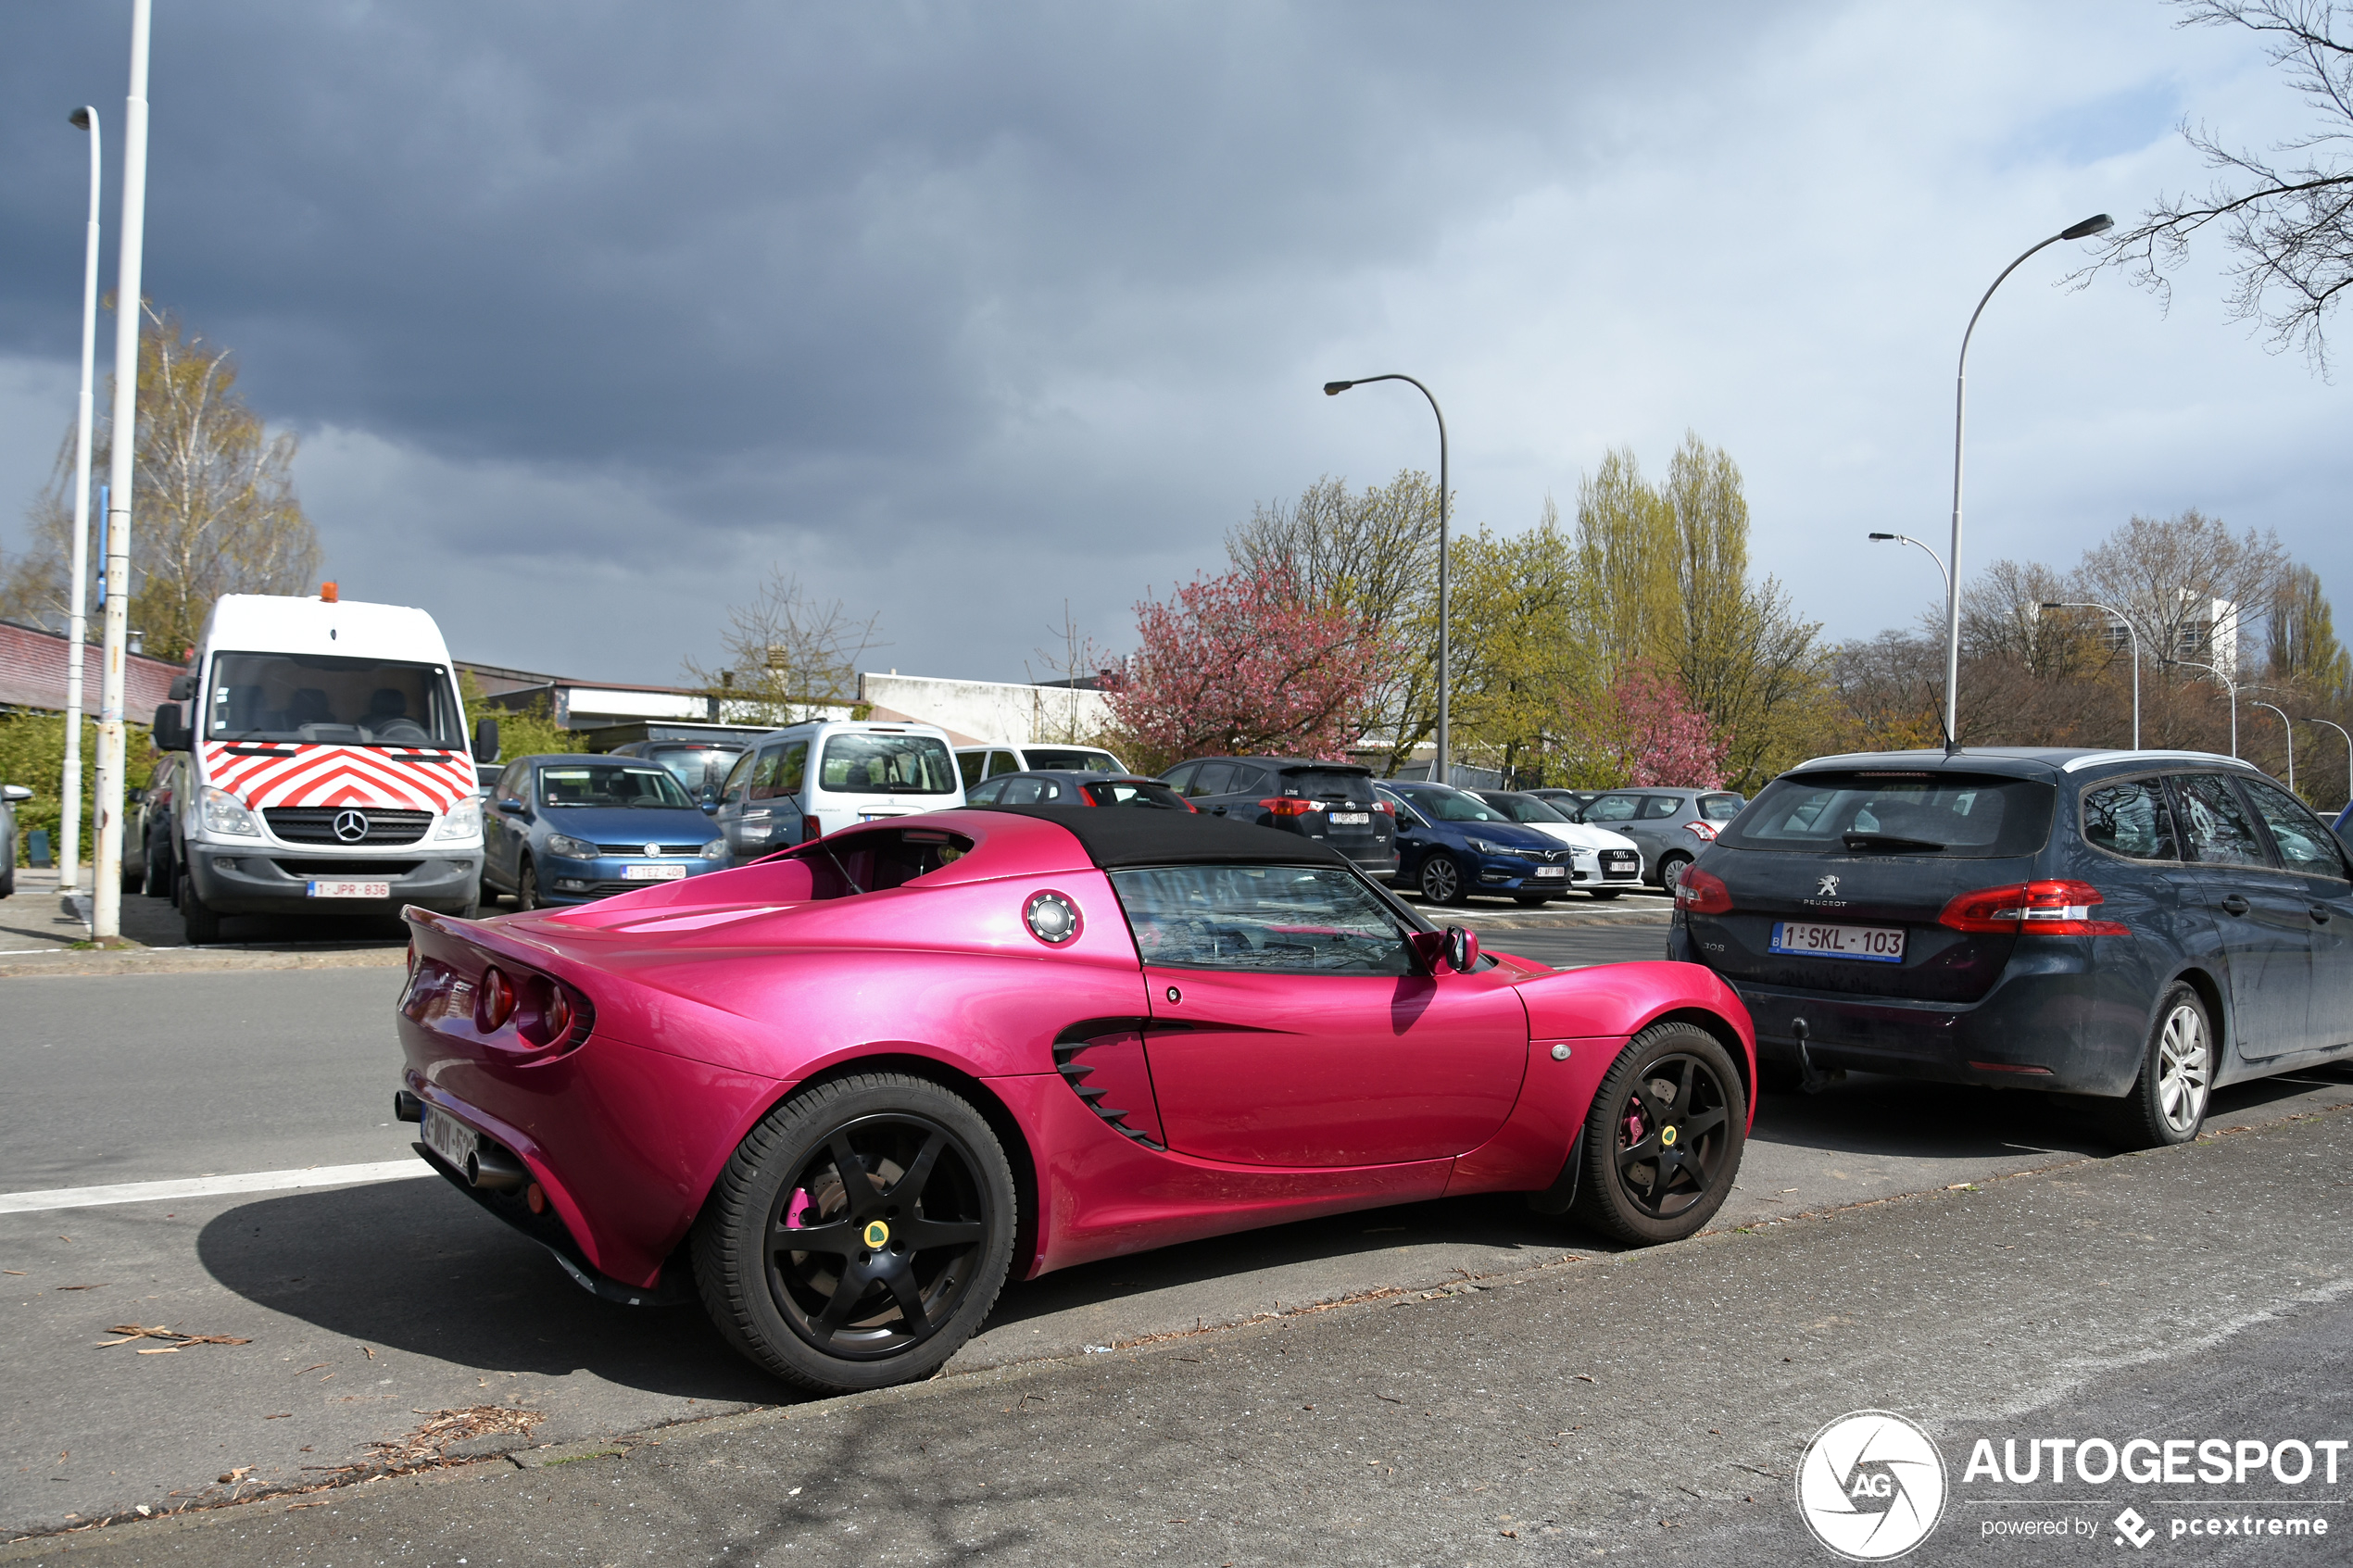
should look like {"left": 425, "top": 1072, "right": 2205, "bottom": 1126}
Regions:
{"left": 396, "top": 807, "right": 1755, "bottom": 1392}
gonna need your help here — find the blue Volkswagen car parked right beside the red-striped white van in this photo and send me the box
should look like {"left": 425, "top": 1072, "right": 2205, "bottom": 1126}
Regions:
{"left": 483, "top": 757, "right": 727, "bottom": 909}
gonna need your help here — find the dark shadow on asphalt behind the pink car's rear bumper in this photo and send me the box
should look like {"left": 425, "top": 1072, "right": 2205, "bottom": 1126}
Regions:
{"left": 195, "top": 1180, "right": 790, "bottom": 1403}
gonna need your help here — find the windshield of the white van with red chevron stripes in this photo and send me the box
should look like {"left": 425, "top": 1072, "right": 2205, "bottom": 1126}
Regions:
{"left": 205, "top": 654, "right": 466, "bottom": 750}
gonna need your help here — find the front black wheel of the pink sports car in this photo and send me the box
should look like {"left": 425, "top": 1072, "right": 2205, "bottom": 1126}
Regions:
{"left": 1574, "top": 1022, "right": 1748, "bottom": 1244}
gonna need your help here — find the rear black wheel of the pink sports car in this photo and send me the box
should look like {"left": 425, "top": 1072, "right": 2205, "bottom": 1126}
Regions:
{"left": 694, "top": 1074, "right": 1016, "bottom": 1392}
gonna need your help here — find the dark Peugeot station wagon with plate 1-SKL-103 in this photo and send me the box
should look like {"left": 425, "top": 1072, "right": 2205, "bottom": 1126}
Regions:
{"left": 1668, "top": 747, "right": 2353, "bottom": 1148}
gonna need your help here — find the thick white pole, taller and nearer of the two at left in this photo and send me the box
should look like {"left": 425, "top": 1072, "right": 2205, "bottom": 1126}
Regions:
{"left": 90, "top": 0, "right": 151, "bottom": 943}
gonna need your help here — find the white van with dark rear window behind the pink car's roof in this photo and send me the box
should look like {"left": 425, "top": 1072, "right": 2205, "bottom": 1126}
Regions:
{"left": 715, "top": 720, "right": 964, "bottom": 865}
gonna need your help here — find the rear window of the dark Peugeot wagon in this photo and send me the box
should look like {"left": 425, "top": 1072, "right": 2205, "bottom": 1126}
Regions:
{"left": 1716, "top": 771, "right": 2057, "bottom": 858}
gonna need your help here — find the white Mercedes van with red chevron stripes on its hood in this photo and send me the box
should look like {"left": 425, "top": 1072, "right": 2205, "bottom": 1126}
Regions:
{"left": 151, "top": 583, "right": 498, "bottom": 943}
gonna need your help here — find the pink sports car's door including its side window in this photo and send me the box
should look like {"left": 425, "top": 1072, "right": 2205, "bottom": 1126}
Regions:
{"left": 1111, "top": 865, "right": 1527, "bottom": 1166}
